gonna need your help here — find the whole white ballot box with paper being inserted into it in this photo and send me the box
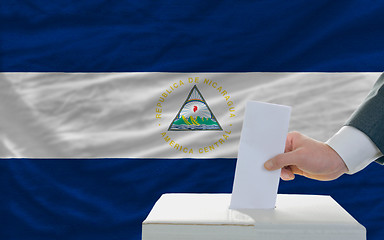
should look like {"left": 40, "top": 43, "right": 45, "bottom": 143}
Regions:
{"left": 142, "top": 194, "right": 366, "bottom": 240}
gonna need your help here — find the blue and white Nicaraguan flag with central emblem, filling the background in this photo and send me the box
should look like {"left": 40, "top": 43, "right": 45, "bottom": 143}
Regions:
{"left": 0, "top": 0, "right": 384, "bottom": 240}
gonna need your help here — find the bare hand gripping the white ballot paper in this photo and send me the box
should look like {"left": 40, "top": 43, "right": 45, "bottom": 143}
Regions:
{"left": 264, "top": 132, "right": 348, "bottom": 181}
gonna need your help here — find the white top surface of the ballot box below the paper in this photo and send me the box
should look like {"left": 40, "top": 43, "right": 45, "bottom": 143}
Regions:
{"left": 143, "top": 194, "right": 365, "bottom": 232}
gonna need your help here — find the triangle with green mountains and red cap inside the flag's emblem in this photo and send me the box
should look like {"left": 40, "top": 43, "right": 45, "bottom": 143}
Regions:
{"left": 168, "top": 85, "right": 223, "bottom": 131}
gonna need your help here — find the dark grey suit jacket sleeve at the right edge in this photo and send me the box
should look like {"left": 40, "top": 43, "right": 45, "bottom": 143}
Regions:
{"left": 345, "top": 73, "right": 384, "bottom": 164}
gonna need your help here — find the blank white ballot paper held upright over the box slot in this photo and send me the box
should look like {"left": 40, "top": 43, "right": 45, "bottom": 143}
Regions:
{"left": 230, "top": 101, "right": 291, "bottom": 209}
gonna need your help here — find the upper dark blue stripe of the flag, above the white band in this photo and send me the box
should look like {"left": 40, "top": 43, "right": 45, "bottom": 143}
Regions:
{"left": 0, "top": 0, "right": 384, "bottom": 72}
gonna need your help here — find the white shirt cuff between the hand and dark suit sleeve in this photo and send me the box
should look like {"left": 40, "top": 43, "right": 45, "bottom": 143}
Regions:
{"left": 326, "top": 126, "right": 383, "bottom": 174}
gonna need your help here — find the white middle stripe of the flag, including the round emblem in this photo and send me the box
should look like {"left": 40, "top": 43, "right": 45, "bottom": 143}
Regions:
{"left": 0, "top": 72, "right": 380, "bottom": 158}
